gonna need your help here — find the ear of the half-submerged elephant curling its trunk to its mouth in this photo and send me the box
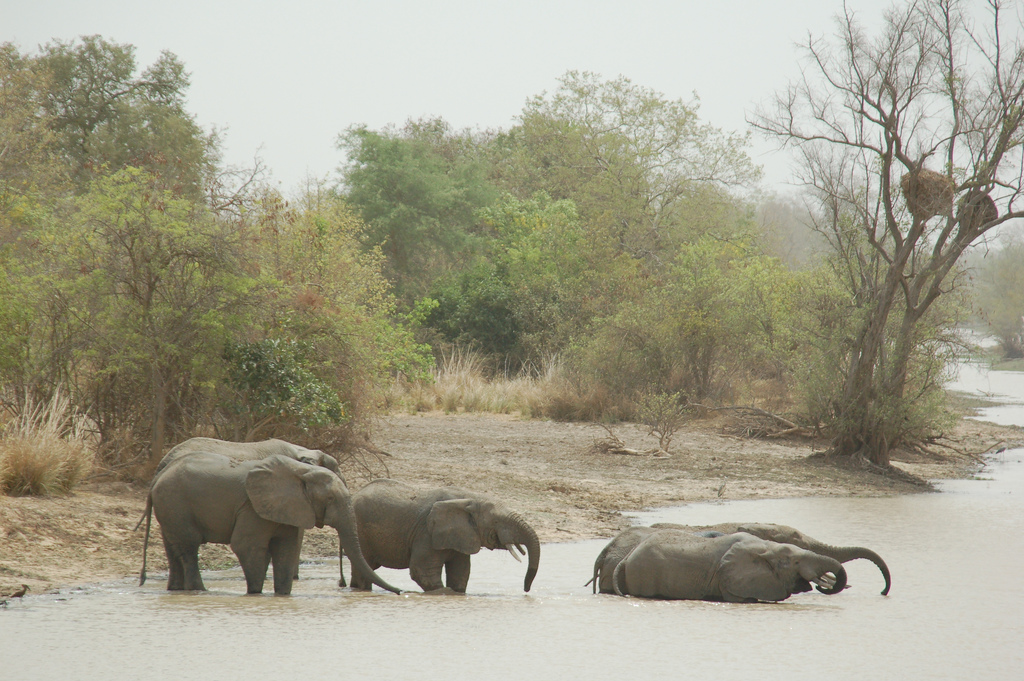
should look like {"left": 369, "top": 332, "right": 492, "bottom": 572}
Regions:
{"left": 718, "top": 537, "right": 792, "bottom": 602}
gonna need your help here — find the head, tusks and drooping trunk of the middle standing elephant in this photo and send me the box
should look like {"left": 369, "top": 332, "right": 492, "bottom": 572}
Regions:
{"left": 427, "top": 498, "right": 541, "bottom": 591}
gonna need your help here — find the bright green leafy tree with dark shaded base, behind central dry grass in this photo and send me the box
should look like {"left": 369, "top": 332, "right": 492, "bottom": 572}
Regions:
{"left": 426, "top": 193, "right": 638, "bottom": 368}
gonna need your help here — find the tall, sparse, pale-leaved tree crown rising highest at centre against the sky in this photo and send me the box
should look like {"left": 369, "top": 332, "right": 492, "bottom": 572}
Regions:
{"left": 503, "top": 71, "right": 759, "bottom": 268}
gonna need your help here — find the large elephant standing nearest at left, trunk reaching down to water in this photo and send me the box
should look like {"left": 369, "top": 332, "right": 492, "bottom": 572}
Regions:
{"left": 142, "top": 452, "right": 400, "bottom": 595}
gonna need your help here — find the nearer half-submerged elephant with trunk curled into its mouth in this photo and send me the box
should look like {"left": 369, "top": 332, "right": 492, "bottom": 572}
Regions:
{"left": 612, "top": 528, "right": 847, "bottom": 603}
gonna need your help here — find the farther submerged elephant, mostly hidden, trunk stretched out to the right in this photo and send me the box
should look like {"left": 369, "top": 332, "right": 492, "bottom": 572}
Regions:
{"left": 587, "top": 522, "right": 892, "bottom": 596}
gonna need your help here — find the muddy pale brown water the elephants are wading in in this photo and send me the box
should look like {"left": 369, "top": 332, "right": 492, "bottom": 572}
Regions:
{"left": 0, "top": 358, "right": 1024, "bottom": 681}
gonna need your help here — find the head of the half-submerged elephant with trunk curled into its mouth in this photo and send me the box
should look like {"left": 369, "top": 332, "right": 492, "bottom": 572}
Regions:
{"left": 717, "top": 535, "right": 847, "bottom": 601}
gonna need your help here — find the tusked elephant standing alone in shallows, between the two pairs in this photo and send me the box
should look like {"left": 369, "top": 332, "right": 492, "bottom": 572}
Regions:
{"left": 352, "top": 479, "right": 541, "bottom": 593}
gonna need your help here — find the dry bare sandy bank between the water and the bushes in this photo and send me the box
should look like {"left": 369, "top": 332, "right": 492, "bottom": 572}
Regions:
{"left": 0, "top": 413, "right": 1024, "bottom": 597}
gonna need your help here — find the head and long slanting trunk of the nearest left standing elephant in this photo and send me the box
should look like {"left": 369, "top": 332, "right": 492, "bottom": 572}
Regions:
{"left": 246, "top": 455, "right": 401, "bottom": 593}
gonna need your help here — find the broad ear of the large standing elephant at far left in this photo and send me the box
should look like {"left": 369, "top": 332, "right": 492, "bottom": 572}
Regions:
{"left": 246, "top": 455, "right": 316, "bottom": 529}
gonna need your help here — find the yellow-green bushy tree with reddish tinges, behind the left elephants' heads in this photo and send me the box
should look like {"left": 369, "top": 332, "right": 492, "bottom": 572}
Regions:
{"left": 245, "top": 182, "right": 431, "bottom": 437}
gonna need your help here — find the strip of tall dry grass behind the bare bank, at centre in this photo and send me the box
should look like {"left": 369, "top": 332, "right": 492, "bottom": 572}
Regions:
{"left": 388, "top": 348, "right": 629, "bottom": 421}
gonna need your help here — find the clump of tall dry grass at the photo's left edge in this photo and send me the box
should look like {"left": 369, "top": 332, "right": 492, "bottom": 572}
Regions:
{"left": 0, "top": 391, "right": 95, "bottom": 497}
